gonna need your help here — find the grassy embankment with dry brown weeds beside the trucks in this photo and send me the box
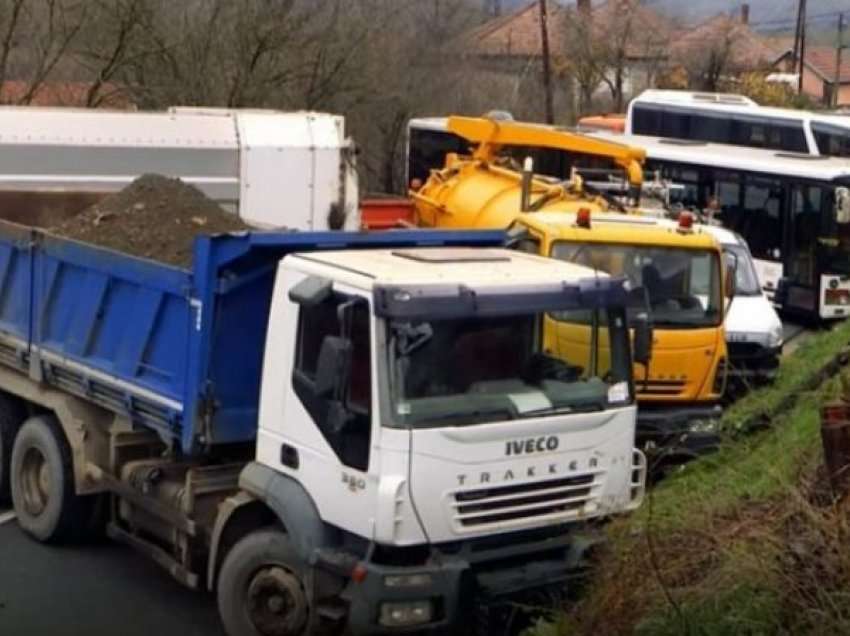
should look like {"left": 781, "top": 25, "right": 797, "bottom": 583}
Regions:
{"left": 529, "top": 321, "right": 850, "bottom": 636}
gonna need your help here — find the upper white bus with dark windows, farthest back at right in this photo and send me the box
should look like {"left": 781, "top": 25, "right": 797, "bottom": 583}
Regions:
{"left": 625, "top": 90, "right": 850, "bottom": 157}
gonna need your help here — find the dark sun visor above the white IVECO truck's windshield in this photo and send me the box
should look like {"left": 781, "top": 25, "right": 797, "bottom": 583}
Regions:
{"left": 374, "top": 277, "right": 629, "bottom": 320}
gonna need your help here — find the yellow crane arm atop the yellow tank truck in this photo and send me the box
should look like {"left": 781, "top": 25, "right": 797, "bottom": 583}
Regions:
{"left": 448, "top": 116, "right": 646, "bottom": 188}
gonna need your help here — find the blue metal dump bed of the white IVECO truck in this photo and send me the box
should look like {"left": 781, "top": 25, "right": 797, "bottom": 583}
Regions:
{"left": 0, "top": 222, "right": 504, "bottom": 454}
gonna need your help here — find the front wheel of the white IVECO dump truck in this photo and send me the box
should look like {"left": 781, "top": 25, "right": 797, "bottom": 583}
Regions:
{"left": 218, "top": 530, "right": 310, "bottom": 636}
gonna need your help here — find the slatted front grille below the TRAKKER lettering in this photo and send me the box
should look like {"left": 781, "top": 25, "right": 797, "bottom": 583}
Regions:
{"left": 452, "top": 471, "right": 602, "bottom": 529}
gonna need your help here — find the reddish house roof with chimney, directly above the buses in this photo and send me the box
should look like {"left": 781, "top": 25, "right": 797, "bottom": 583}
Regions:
{"left": 670, "top": 13, "right": 776, "bottom": 68}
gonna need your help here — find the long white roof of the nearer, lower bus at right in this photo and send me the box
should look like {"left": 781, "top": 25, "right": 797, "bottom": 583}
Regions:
{"left": 589, "top": 132, "right": 850, "bottom": 181}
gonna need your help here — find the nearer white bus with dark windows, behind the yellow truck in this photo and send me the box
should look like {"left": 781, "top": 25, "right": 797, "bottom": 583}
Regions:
{"left": 594, "top": 133, "right": 850, "bottom": 319}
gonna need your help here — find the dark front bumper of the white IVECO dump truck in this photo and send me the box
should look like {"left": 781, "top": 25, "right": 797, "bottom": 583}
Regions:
{"left": 343, "top": 535, "right": 597, "bottom": 636}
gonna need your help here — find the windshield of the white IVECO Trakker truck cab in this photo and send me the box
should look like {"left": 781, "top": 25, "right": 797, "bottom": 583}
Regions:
{"left": 389, "top": 310, "right": 632, "bottom": 427}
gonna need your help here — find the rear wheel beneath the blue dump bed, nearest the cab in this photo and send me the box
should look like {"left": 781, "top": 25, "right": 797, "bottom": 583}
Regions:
{"left": 11, "top": 415, "right": 92, "bottom": 543}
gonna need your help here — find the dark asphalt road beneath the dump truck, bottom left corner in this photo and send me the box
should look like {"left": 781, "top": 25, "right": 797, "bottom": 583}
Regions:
{"left": 0, "top": 510, "right": 223, "bottom": 636}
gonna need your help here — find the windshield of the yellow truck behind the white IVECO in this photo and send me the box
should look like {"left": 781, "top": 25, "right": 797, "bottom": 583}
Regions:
{"left": 551, "top": 241, "right": 722, "bottom": 328}
